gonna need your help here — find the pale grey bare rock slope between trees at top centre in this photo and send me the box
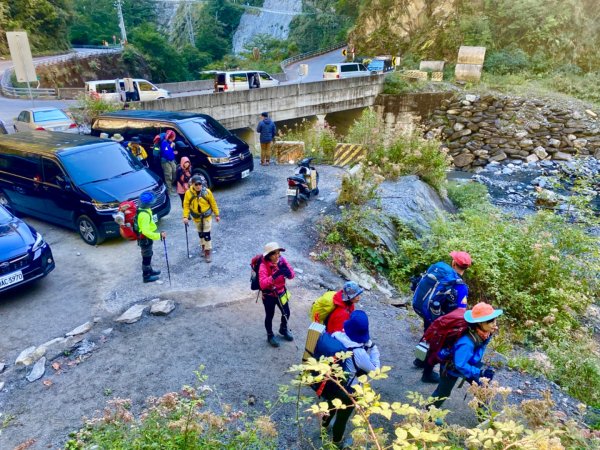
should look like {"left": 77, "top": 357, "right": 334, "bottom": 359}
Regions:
{"left": 233, "top": 0, "right": 302, "bottom": 53}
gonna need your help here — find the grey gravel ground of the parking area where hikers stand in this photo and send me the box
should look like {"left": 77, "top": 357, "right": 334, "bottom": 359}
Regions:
{"left": 0, "top": 161, "right": 592, "bottom": 449}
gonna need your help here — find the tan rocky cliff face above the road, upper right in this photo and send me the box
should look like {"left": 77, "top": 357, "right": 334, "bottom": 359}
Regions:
{"left": 349, "top": 0, "right": 460, "bottom": 54}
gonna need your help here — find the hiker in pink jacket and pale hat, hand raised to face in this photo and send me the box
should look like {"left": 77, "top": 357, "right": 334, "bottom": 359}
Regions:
{"left": 258, "top": 242, "right": 294, "bottom": 347}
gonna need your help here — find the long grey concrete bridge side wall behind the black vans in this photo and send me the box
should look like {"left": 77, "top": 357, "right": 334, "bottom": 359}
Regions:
{"left": 136, "top": 75, "right": 384, "bottom": 130}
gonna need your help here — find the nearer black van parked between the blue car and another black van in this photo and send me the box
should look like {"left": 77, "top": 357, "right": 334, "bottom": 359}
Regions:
{"left": 0, "top": 131, "right": 171, "bottom": 245}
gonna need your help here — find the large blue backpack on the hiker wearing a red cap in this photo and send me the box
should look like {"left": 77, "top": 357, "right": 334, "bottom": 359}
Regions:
{"left": 413, "top": 262, "right": 465, "bottom": 322}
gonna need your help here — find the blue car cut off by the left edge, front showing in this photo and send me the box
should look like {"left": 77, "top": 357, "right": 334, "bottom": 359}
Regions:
{"left": 0, "top": 205, "right": 54, "bottom": 292}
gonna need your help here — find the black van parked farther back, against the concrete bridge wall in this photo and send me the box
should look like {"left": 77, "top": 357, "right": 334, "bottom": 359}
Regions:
{"left": 92, "top": 110, "right": 254, "bottom": 187}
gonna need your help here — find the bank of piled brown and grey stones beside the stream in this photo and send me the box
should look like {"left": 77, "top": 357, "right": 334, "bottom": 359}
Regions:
{"left": 426, "top": 94, "right": 600, "bottom": 170}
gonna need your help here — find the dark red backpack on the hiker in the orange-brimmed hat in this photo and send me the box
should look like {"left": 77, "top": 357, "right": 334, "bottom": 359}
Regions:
{"left": 423, "top": 308, "right": 469, "bottom": 366}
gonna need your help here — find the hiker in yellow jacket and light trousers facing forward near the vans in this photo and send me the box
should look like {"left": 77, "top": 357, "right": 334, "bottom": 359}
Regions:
{"left": 182, "top": 175, "right": 221, "bottom": 263}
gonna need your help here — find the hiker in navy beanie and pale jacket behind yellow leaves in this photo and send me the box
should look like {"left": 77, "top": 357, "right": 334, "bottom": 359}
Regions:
{"left": 312, "top": 310, "right": 381, "bottom": 448}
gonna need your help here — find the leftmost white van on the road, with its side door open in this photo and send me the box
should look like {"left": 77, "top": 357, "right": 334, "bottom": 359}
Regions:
{"left": 85, "top": 78, "right": 171, "bottom": 103}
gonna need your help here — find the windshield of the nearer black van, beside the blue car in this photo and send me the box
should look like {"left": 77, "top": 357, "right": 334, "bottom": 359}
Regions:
{"left": 61, "top": 143, "right": 143, "bottom": 186}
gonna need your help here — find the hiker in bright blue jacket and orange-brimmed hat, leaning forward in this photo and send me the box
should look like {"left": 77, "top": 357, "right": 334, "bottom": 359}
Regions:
{"left": 431, "top": 302, "right": 503, "bottom": 408}
